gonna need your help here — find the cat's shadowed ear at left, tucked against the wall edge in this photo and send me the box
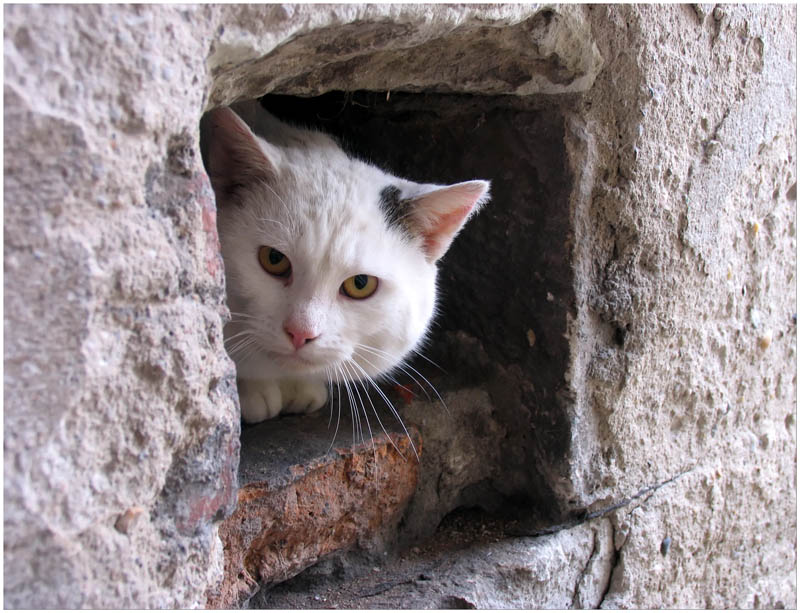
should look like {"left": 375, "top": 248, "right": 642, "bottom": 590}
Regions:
{"left": 203, "top": 107, "right": 280, "bottom": 204}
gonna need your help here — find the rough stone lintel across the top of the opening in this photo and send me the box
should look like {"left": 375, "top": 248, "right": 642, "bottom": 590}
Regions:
{"left": 208, "top": 4, "right": 602, "bottom": 105}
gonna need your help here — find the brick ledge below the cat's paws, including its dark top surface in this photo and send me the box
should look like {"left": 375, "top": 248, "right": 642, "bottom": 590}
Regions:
{"left": 208, "top": 415, "right": 422, "bottom": 609}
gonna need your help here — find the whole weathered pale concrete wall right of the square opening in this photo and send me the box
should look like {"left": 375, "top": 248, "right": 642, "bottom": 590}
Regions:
{"left": 570, "top": 6, "right": 797, "bottom": 607}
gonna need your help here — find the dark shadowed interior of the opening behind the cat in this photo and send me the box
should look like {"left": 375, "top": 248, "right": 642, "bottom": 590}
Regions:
{"left": 219, "top": 91, "right": 574, "bottom": 524}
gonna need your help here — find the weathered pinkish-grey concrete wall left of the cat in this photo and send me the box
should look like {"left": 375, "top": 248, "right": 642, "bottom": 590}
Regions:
{"left": 4, "top": 6, "right": 239, "bottom": 608}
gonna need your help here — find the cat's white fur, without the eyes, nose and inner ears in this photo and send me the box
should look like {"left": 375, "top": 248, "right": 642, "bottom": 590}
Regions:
{"left": 210, "top": 105, "right": 488, "bottom": 422}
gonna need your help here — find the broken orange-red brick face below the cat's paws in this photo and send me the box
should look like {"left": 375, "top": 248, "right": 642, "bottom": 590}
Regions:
{"left": 208, "top": 430, "right": 421, "bottom": 608}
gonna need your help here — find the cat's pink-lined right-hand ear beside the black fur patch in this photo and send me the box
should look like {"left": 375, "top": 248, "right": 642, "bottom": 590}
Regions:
{"left": 408, "top": 181, "right": 489, "bottom": 262}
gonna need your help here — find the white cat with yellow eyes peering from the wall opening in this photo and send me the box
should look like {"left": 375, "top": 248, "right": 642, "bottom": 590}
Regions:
{"left": 204, "top": 101, "right": 489, "bottom": 423}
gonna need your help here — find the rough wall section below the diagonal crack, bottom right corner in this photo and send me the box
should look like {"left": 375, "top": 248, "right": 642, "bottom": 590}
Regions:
{"left": 602, "top": 466, "right": 797, "bottom": 609}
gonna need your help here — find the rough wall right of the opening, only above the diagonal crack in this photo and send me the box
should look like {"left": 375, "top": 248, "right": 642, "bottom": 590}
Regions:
{"left": 569, "top": 0, "right": 796, "bottom": 510}
